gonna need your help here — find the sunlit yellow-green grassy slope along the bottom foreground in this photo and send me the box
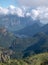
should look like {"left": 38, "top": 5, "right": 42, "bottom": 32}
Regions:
{"left": 0, "top": 53, "right": 48, "bottom": 65}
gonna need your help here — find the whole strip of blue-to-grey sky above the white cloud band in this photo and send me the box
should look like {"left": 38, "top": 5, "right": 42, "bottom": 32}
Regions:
{"left": 0, "top": 0, "right": 48, "bottom": 7}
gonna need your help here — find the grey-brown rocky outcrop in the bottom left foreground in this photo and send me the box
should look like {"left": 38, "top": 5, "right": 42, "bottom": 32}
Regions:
{"left": 0, "top": 49, "right": 12, "bottom": 63}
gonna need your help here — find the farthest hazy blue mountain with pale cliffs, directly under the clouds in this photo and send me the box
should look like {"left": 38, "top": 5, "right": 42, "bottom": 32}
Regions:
{"left": 0, "top": 14, "right": 41, "bottom": 31}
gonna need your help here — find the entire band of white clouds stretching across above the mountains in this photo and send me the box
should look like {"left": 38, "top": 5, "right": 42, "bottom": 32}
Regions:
{"left": 0, "top": 5, "right": 48, "bottom": 24}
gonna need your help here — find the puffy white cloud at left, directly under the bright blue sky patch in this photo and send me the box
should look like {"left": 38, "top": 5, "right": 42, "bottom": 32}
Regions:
{"left": 0, "top": 5, "right": 24, "bottom": 17}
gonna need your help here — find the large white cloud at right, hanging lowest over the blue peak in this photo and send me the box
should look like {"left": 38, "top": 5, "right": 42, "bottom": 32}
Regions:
{"left": 32, "top": 7, "right": 48, "bottom": 24}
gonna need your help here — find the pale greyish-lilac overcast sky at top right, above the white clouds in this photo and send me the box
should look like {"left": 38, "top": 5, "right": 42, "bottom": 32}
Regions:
{"left": 17, "top": 0, "right": 48, "bottom": 7}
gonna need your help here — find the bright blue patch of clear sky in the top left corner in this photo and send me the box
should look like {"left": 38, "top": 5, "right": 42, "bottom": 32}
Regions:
{"left": 0, "top": 0, "right": 18, "bottom": 7}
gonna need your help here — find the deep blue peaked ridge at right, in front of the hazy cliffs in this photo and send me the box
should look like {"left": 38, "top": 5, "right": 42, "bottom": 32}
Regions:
{"left": 14, "top": 20, "right": 48, "bottom": 37}
